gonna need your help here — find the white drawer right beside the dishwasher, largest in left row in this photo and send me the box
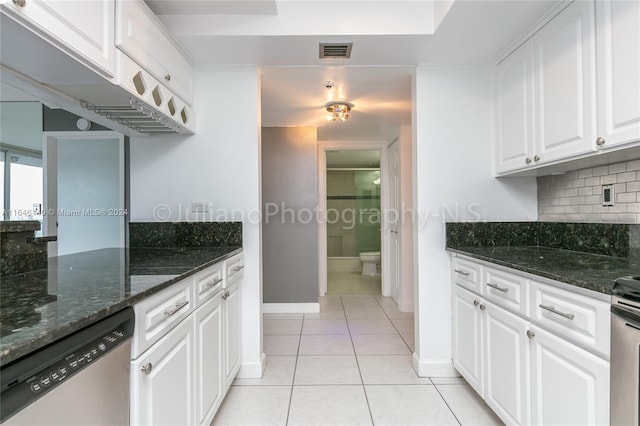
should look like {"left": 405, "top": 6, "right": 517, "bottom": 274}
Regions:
{"left": 131, "top": 278, "right": 194, "bottom": 359}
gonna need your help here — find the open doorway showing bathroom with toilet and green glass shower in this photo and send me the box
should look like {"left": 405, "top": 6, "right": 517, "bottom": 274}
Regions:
{"left": 318, "top": 143, "right": 388, "bottom": 296}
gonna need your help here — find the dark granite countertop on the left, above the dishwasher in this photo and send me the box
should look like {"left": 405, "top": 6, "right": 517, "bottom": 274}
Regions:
{"left": 0, "top": 246, "right": 241, "bottom": 365}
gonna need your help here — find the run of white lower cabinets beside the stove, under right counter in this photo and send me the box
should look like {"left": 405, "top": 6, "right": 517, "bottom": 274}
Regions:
{"left": 452, "top": 255, "right": 609, "bottom": 425}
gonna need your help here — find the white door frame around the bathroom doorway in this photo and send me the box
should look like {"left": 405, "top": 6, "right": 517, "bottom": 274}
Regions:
{"left": 318, "top": 141, "right": 390, "bottom": 297}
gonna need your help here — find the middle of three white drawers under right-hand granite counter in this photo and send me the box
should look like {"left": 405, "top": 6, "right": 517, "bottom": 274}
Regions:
{"left": 483, "top": 267, "right": 529, "bottom": 316}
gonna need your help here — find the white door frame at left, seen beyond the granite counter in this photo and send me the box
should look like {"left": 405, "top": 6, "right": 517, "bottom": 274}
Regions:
{"left": 42, "top": 130, "right": 130, "bottom": 257}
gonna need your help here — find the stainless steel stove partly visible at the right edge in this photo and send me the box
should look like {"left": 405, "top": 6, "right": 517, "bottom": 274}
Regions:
{"left": 610, "top": 277, "right": 640, "bottom": 426}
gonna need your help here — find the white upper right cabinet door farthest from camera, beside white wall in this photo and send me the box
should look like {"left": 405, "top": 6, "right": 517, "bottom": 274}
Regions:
{"left": 494, "top": 40, "right": 534, "bottom": 173}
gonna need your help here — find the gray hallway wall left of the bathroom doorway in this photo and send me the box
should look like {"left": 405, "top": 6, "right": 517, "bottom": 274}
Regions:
{"left": 262, "top": 127, "right": 318, "bottom": 303}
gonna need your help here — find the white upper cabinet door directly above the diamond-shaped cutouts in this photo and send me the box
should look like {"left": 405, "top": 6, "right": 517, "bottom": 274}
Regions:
{"left": 115, "top": 0, "right": 194, "bottom": 105}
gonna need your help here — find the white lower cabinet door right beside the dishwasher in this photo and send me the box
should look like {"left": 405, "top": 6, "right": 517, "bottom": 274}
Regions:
{"left": 130, "top": 317, "right": 196, "bottom": 425}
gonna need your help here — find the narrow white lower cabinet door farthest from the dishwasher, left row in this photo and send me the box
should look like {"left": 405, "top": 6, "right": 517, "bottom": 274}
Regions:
{"left": 224, "top": 280, "right": 241, "bottom": 390}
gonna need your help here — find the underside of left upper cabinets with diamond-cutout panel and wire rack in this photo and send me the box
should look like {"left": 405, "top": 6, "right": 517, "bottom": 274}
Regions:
{"left": 0, "top": 14, "right": 195, "bottom": 136}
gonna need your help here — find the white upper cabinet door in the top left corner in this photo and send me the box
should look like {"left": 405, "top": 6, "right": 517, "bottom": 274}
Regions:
{"left": 1, "top": 0, "right": 116, "bottom": 79}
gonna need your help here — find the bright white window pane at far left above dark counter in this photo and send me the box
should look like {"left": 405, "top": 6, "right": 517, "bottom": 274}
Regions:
{"left": 8, "top": 153, "right": 42, "bottom": 221}
